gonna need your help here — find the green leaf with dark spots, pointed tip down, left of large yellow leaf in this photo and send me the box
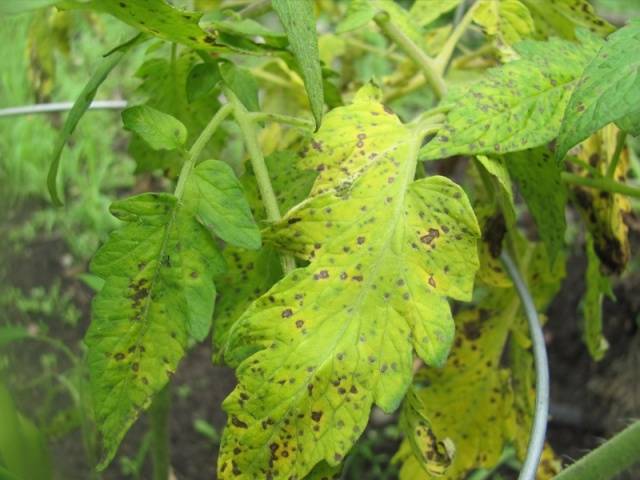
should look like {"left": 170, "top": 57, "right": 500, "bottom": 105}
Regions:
{"left": 85, "top": 161, "right": 259, "bottom": 468}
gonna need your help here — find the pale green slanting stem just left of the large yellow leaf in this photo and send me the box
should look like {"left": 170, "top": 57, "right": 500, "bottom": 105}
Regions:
{"left": 223, "top": 87, "right": 295, "bottom": 274}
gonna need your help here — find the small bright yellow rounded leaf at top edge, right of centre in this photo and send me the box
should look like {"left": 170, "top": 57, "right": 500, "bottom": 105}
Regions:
{"left": 473, "top": 0, "right": 535, "bottom": 45}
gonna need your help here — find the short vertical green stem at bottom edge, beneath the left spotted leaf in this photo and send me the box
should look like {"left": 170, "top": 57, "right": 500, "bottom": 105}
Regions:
{"left": 149, "top": 384, "right": 171, "bottom": 480}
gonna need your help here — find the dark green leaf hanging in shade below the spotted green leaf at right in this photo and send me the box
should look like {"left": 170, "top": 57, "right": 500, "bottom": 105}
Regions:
{"left": 505, "top": 147, "right": 567, "bottom": 262}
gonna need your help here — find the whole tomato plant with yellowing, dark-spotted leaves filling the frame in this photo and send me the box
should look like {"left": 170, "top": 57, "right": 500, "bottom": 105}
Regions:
{"left": 2, "top": 0, "right": 640, "bottom": 479}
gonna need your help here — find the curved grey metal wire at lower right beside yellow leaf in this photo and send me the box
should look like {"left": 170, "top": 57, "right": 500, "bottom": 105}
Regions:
{"left": 500, "top": 251, "right": 549, "bottom": 480}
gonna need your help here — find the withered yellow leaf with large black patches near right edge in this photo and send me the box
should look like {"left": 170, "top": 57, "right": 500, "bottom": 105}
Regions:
{"left": 573, "top": 125, "right": 631, "bottom": 274}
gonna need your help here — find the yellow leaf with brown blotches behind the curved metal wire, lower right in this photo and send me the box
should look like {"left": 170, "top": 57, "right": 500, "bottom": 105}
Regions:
{"left": 396, "top": 242, "right": 563, "bottom": 480}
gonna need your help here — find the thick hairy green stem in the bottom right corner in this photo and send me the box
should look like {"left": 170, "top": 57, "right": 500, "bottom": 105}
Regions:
{"left": 555, "top": 421, "right": 640, "bottom": 480}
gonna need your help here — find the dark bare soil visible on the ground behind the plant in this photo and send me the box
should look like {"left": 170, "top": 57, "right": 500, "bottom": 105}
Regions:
{"left": 8, "top": 218, "right": 640, "bottom": 480}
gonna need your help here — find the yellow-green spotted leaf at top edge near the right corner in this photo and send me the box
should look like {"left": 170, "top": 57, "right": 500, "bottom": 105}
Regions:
{"left": 521, "top": 0, "right": 615, "bottom": 40}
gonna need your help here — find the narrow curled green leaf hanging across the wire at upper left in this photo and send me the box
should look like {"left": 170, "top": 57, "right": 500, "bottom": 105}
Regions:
{"left": 47, "top": 35, "right": 144, "bottom": 206}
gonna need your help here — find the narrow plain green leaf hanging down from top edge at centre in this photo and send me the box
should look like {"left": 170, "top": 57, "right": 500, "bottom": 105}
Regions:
{"left": 272, "top": 0, "right": 324, "bottom": 127}
